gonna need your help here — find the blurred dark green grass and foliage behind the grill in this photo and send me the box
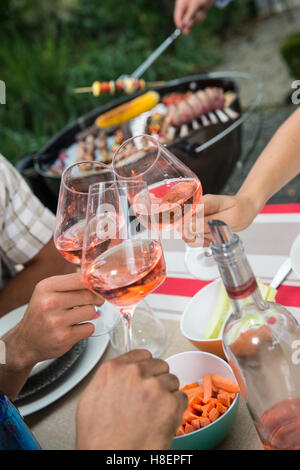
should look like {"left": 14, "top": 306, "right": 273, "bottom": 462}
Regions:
{"left": 0, "top": 0, "right": 255, "bottom": 163}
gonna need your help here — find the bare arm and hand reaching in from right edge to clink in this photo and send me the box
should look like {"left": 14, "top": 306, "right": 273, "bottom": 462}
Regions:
{"left": 202, "top": 105, "right": 300, "bottom": 244}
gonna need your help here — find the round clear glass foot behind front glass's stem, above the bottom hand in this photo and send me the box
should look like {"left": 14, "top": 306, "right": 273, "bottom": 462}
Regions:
{"left": 109, "top": 300, "right": 167, "bottom": 358}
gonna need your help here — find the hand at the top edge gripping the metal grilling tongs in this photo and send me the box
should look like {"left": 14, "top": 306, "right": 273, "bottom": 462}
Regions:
{"left": 174, "top": 0, "right": 214, "bottom": 34}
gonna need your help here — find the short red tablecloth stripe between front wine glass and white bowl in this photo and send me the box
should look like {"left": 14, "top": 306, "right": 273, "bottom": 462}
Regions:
{"left": 154, "top": 277, "right": 212, "bottom": 297}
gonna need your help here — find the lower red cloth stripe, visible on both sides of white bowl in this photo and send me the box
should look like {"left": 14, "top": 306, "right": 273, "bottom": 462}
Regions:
{"left": 154, "top": 277, "right": 300, "bottom": 307}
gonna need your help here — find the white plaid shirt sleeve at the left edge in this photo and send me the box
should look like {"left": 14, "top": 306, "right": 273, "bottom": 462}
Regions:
{"left": 0, "top": 155, "right": 55, "bottom": 288}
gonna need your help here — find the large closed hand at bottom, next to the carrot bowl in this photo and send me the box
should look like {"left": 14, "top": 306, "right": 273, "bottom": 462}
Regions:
{"left": 77, "top": 349, "right": 188, "bottom": 450}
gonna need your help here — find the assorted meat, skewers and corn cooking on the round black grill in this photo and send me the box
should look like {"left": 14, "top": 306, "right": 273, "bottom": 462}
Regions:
{"left": 48, "top": 85, "right": 238, "bottom": 175}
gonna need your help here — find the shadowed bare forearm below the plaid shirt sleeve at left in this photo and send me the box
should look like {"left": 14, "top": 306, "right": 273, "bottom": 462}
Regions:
{"left": 0, "top": 239, "right": 75, "bottom": 317}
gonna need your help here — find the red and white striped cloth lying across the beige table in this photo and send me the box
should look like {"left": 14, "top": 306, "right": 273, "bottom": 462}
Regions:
{"left": 147, "top": 204, "right": 300, "bottom": 319}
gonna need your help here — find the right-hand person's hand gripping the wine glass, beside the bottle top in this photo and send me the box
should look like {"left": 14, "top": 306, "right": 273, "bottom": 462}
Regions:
{"left": 201, "top": 194, "right": 257, "bottom": 246}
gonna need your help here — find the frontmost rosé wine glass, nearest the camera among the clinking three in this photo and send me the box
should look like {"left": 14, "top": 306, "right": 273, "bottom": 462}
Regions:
{"left": 81, "top": 181, "right": 166, "bottom": 352}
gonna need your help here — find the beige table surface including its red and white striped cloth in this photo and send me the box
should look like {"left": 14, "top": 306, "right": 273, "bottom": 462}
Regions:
{"left": 25, "top": 204, "right": 300, "bottom": 450}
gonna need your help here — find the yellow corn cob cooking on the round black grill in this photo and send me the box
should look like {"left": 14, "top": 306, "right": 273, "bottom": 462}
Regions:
{"left": 96, "top": 91, "right": 160, "bottom": 129}
